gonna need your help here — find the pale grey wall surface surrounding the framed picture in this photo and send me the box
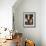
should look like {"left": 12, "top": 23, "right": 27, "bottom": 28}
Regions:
{"left": 13, "top": 0, "right": 41, "bottom": 46}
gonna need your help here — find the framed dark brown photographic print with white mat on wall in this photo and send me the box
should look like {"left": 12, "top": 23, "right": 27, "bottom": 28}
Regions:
{"left": 23, "top": 12, "right": 36, "bottom": 28}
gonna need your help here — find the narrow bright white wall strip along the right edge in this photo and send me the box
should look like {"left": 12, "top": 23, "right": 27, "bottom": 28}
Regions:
{"left": 40, "top": 0, "right": 46, "bottom": 46}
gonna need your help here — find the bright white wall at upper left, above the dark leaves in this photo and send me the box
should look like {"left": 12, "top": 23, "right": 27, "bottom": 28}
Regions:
{"left": 0, "top": 0, "right": 16, "bottom": 29}
